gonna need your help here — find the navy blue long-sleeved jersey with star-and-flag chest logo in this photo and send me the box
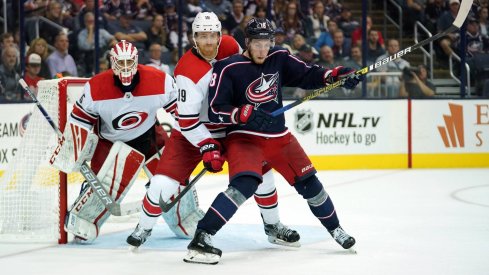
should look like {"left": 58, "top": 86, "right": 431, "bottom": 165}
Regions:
{"left": 208, "top": 47, "right": 326, "bottom": 137}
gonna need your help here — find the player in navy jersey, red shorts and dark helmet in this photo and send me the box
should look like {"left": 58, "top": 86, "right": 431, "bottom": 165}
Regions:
{"left": 184, "top": 18, "right": 361, "bottom": 264}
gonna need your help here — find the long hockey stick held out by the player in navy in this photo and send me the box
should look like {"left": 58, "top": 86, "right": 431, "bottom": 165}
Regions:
{"left": 271, "top": 0, "right": 474, "bottom": 117}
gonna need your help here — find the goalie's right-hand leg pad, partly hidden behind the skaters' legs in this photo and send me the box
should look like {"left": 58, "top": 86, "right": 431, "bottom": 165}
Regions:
{"left": 162, "top": 186, "right": 205, "bottom": 239}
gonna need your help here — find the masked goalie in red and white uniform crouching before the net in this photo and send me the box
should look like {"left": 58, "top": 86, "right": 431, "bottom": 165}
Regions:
{"left": 52, "top": 40, "right": 177, "bottom": 241}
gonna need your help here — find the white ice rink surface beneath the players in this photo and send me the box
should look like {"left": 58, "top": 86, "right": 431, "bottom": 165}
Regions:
{"left": 0, "top": 169, "right": 489, "bottom": 275}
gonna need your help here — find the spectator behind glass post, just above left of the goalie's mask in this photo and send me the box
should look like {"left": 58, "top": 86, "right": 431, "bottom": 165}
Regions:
{"left": 77, "top": 12, "right": 116, "bottom": 76}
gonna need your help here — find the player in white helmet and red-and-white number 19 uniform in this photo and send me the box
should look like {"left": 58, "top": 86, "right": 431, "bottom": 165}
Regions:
{"left": 127, "top": 12, "right": 300, "bottom": 250}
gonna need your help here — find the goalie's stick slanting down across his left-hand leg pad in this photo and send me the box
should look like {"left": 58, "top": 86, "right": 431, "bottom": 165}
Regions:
{"left": 19, "top": 78, "right": 127, "bottom": 216}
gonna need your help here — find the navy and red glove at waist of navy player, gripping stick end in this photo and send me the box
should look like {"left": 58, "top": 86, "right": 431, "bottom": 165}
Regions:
{"left": 234, "top": 104, "right": 275, "bottom": 131}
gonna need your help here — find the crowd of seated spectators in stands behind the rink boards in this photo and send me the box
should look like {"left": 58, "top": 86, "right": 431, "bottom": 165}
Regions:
{"left": 0, "top": 0, "right": 489, "bottom": 101}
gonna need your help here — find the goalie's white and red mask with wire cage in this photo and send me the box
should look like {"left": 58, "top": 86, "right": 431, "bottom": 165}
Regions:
{"left": 110, "top": 40, "right": 138, "bottom": 86}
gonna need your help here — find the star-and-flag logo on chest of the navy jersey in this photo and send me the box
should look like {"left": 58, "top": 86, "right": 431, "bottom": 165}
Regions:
{"left": 246, "top": 72, "right": 278, "bottom": 106}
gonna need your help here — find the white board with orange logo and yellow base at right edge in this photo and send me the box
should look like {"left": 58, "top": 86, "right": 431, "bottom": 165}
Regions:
{"left": 412, "top": 100, "right": 489, "bottom": 167}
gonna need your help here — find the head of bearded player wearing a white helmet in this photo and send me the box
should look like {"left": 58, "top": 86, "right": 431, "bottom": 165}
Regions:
{"left": 192, "top": 12, "right": 221, "bottom": 61}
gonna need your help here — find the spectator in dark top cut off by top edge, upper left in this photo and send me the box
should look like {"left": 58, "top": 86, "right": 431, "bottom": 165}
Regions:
{"left": 39, "top": 1, "right": 73, "bottom": 45}
